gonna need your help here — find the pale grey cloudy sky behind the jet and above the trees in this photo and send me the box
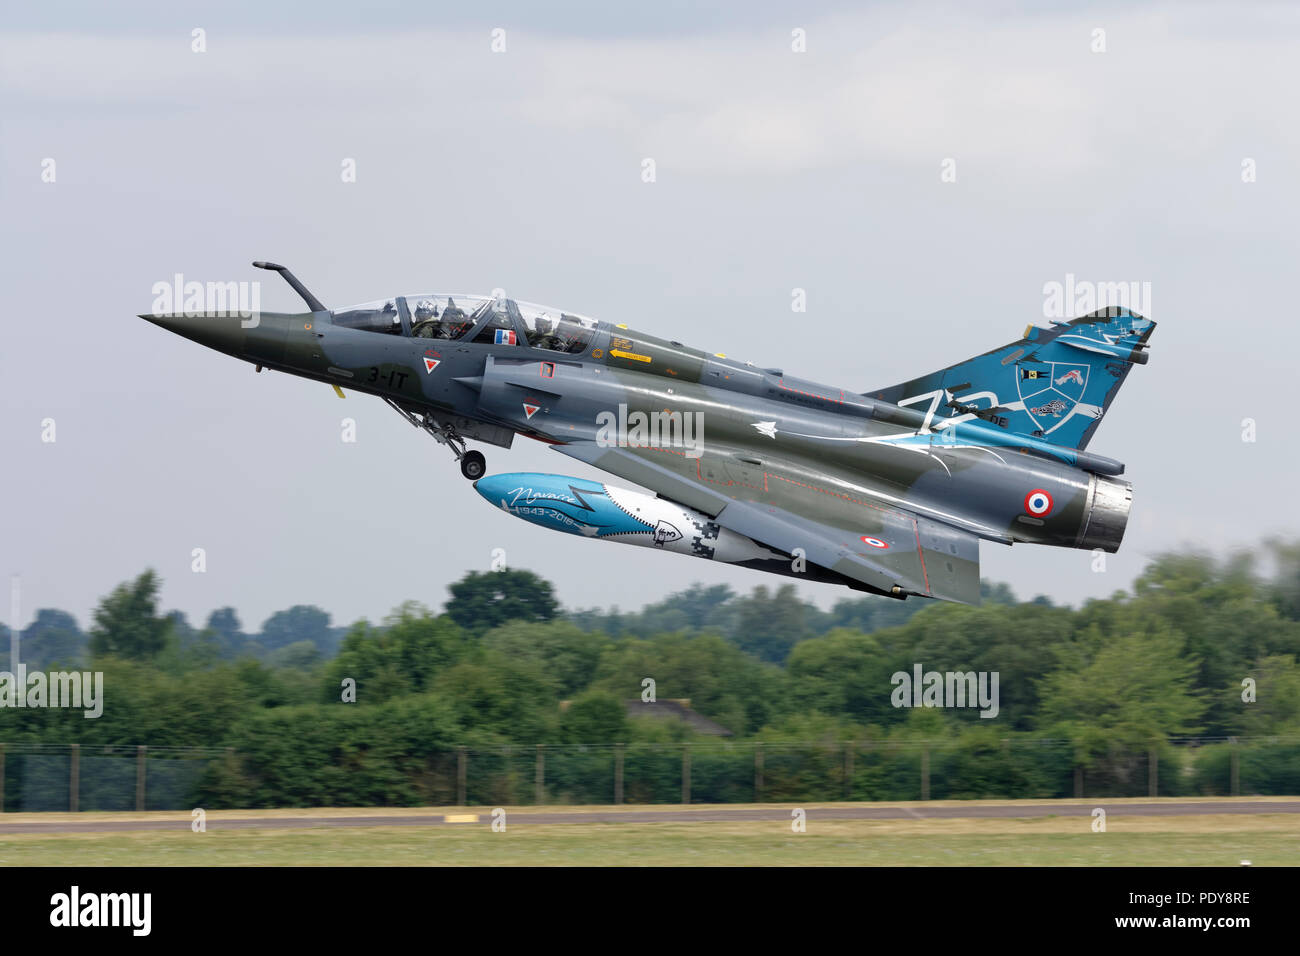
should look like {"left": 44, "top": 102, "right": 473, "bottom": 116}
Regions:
{"left": 0, "top": 3, "right": 1300, "bottom": 630}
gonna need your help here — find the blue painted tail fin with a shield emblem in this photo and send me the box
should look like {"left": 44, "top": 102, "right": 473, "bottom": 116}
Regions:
{"left": 865, "top": 306, "right": 1156, "bottom": 449}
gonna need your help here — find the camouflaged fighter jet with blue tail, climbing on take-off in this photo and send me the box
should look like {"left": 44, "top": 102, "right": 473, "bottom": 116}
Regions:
{"left": 140, "top": 261, "right": 1156, "bottom": 604}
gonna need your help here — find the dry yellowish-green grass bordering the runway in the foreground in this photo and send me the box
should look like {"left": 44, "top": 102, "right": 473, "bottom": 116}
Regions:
{"left": 0, "top": 801, "right": 1300, "bottom": 866}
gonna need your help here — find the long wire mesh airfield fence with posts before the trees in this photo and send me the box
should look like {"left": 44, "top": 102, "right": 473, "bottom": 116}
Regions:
{"left": 0, "top": 737, "right": 1300, "bottom": 812}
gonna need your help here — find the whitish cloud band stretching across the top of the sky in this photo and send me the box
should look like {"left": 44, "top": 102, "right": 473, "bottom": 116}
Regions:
{"left": 0, "top": 5, "right": 1300, "bottom": 178}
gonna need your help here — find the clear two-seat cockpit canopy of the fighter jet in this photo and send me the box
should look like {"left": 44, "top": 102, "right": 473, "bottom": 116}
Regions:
{"left": 333, "top": 293, "right": 597, "bottom": 354}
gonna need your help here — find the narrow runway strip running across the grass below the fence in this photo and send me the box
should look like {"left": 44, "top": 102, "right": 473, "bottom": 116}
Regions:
{"left": 0, "top": 799, "right": 1300, "bottom": 835}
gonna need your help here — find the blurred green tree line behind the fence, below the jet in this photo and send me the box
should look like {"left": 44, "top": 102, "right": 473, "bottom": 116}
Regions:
{"left": 0, "top": 542, "right": 1300, "bottom": 806}
